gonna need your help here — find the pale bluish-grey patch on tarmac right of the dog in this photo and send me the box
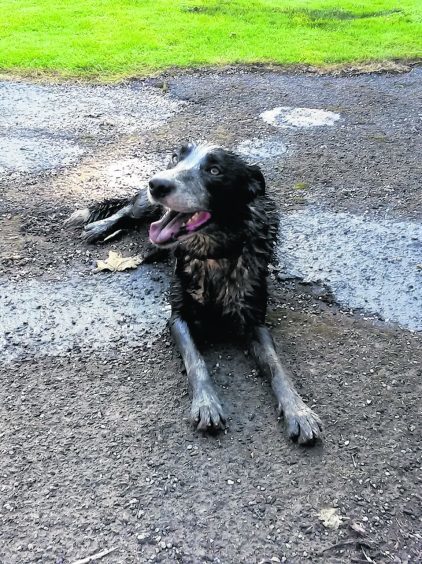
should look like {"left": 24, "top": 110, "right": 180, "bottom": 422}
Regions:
{"left": 278, "top": 209, "right": 422, "bottom": 331}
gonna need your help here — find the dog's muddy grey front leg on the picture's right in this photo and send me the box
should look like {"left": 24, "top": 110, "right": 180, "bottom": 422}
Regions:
{"left": 251, "top": 325, "right": 322, "bottom": 445}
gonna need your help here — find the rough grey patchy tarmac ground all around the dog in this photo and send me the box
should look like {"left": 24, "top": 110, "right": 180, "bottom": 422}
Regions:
{"left": 0, "top": 68, "right": 422, "bottom": 564}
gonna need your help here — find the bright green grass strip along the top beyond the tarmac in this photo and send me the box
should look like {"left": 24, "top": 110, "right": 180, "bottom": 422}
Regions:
{"left": 0, "top": 0, "right": 422, "bottom": 79}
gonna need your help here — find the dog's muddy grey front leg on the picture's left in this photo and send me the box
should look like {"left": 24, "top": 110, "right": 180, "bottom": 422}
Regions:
{"left": 170, "top": 316, "right": 225, "bottom": 431}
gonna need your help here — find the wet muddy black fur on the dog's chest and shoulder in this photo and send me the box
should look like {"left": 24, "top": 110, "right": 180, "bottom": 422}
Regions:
{"left": 171, "top": 194, "right": 278, "bottom": 333}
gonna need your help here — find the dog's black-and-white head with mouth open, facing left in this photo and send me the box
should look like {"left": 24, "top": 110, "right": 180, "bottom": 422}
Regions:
{"left": 149, "top": 144, "right": 265, "bottom": 247}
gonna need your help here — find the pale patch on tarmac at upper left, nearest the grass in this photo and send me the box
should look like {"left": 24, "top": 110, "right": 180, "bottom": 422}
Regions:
{"left": 0, "top": 82, "right": 184, "bottom": 135}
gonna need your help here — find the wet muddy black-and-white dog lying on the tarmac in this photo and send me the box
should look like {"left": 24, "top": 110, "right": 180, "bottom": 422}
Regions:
{"left": 67, "top": 144, "right": 321, "bottom": 444}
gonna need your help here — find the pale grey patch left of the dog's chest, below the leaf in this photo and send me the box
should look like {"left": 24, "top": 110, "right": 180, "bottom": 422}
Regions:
{"left": 0, "top": 266, "right": 170, "bottom": 361}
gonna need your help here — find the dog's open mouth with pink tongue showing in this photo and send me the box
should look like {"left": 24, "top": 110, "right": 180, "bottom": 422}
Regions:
{"left": 149, "top": 210, "right": 211, "bottom": 245}
